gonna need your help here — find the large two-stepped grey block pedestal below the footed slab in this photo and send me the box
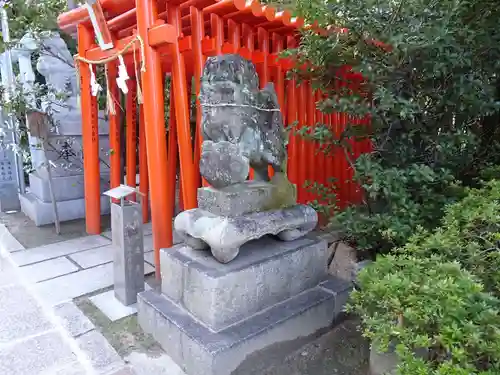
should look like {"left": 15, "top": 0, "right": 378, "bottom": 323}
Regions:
{"left": 138, "top": 235, "right": 351, "bottom": 375}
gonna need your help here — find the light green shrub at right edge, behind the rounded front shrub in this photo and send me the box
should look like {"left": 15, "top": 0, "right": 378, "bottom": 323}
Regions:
{"left": 398, "top": 180, "right": 500, "bottom": 297}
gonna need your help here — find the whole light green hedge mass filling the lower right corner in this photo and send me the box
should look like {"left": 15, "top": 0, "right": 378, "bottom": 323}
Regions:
{"left": 348, "top": 181, "right": 500, "bottom": 375}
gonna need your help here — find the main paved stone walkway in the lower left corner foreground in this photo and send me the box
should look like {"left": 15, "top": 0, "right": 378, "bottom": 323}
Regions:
{"left": 0, "top": 226, "right": 133, "bottom": 375}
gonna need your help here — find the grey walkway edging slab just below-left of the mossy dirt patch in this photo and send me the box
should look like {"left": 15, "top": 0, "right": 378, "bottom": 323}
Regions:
{"left": 77, "top": 331, "right": 124, "bottom": 374}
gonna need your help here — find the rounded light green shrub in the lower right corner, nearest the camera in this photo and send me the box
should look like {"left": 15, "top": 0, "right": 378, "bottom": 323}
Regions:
{"left": 349, "top": 254, "right": 500, "bottom": 375}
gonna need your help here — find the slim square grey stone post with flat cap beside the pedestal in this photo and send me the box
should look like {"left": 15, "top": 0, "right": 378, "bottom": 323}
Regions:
{"left": 104, "top": 185, "right": 144, "bottom": 306}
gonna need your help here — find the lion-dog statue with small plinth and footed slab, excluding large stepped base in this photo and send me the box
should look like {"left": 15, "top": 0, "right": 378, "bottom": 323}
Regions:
{"left": 174, "top": 55, "right": 318, "bottom": 263}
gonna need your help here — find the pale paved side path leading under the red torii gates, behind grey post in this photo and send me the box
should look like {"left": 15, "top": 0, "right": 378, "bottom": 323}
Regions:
{"left": 0, "top": 224, "right": 179, "bottom": 305}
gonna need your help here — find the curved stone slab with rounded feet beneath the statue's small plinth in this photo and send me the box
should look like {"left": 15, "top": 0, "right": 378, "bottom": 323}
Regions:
{"left": 174, "top": 205, "right": 318, "bottom": 263}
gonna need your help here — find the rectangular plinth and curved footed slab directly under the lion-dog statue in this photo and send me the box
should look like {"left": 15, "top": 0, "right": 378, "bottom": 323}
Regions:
{"left": 174, "top": 181, "right": 318, "bottom": 263}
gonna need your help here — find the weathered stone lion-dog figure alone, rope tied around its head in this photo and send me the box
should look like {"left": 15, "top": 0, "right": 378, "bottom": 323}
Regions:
{"left": 200, "top": 55, "right": 286, "bottom": 188}
